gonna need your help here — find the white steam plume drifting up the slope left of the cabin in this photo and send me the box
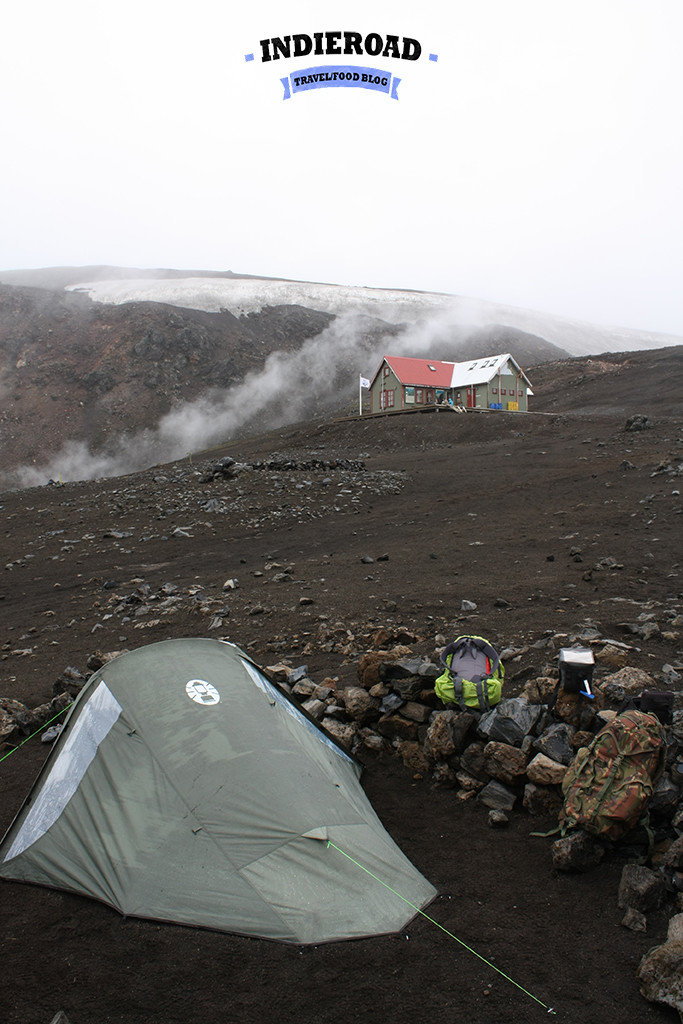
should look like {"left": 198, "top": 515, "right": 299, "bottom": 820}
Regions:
{"left": 2, "top": 309, "right": 481, "bottom": 487}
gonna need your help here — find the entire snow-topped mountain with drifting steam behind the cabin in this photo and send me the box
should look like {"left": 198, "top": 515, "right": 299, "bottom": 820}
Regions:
{"left": 0, "top": 266, "right": 681, "bottom": 485}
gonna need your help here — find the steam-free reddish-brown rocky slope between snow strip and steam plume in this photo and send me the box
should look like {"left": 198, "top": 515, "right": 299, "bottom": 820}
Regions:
{"left": 0, "top": 286, "right": 333, "bottom": 471}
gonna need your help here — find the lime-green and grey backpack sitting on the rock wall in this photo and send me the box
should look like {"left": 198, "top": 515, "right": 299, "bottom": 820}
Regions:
{"left": 434, "top": 636, "right": 505, "bottom": 711}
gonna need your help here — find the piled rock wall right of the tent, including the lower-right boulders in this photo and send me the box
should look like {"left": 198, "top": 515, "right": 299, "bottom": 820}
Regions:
{"left": 269, "top": 640, "right": 683, "bottom": 1020}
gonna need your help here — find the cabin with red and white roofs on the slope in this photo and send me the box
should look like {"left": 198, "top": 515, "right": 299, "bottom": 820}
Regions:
{"left": 370, "top": 352, "right": 533, "bottom": 413}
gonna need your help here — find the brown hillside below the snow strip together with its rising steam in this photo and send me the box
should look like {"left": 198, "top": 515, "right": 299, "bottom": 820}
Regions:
{"left": 0, "top": 285, "right": 566, "bottom": 485}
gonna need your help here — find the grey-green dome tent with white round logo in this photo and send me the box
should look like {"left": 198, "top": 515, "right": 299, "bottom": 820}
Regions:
{"left": 0, "top": 639, "right": 435, "bottom": 943}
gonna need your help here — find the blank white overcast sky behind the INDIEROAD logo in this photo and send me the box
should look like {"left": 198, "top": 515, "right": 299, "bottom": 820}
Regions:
{"left": 0, "top": 0, "right": 683, "bottom": 335}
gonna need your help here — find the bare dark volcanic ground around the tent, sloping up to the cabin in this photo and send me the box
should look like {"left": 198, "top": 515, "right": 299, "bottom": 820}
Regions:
{"left": 0, "top": 360, "right": 683, "bottom": 1024}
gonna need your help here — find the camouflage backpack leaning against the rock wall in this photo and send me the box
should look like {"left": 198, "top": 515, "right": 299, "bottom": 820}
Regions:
{"left": 560, "top": 711, "right": 667, "bottom": 840}
